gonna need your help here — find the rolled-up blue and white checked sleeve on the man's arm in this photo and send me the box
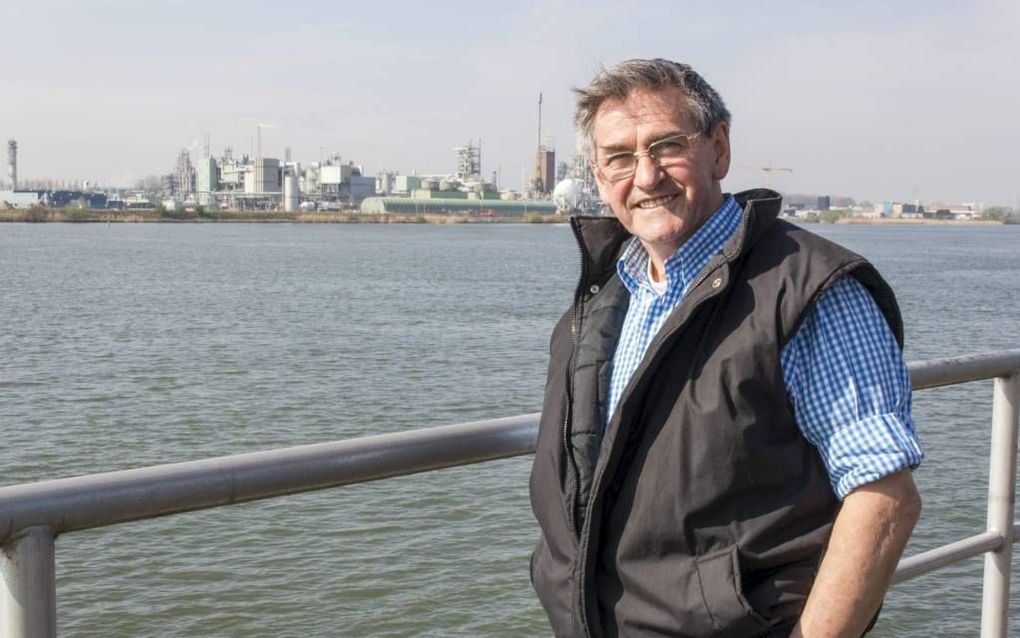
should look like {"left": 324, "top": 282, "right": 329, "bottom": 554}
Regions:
{"left": 780, "top": 276, "right": 924, "bottom": 500}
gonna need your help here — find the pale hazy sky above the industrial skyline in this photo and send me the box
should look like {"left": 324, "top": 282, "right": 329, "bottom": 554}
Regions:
{"left": 0, "top": 0, "right": 1020, "bottom": 206}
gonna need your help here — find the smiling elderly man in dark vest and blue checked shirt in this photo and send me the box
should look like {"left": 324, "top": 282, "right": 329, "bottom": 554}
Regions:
{"left": 531, "top": 59, "right": 922, "bottom": 637}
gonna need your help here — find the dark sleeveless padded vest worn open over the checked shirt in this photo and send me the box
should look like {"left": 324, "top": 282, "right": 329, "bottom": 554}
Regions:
{"left": 530, "top": 190, "right": 903, "bottom": 637}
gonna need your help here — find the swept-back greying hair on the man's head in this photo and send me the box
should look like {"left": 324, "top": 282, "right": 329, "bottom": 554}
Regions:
{"left": 574, "top": 58, "right": 729, "bottom": 161}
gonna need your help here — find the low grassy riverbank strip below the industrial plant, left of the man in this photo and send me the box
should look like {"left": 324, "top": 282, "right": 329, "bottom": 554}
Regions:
{"left": 0, "top": 208, "right": 566, "bottom": 224}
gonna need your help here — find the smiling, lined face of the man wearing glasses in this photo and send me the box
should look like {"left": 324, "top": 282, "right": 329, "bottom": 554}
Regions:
{"left": 594, "top": 87, "right": 729, "bottom": 259}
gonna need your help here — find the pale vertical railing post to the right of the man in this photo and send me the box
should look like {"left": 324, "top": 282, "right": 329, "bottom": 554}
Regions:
{"left": 981, "top": 373, "right": 1020, "bottom": 638}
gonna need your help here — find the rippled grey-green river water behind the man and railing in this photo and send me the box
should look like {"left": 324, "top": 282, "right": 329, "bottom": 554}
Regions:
{"left": 0, "top": 224, "right": 1020, "bottom": 637}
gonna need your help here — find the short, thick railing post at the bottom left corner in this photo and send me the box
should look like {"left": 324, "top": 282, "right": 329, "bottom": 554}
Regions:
{"left": 0, "top": 527, "right": 57, "bottom": 638}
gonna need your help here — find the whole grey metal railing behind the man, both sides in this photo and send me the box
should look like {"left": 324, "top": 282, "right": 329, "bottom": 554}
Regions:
{"left": 0, "top": 350, "right": 1020, "bottom": 638}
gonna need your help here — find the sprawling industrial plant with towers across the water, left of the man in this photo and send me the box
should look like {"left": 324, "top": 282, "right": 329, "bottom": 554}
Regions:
{"left": 0, "top": 94, "right": 597, "bottom": 217}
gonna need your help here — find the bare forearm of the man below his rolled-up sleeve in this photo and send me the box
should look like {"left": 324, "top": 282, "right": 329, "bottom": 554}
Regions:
{"left": 791, "top": 470, "right": 921, "bottom": 638}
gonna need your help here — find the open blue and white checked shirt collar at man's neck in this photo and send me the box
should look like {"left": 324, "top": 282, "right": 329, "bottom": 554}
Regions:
{"left": 616, "top": 195, "right": 742, "bottom": 294}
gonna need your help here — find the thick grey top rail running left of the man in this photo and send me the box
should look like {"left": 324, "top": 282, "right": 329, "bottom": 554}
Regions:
{"left": 0, "top": 413, "right": 539, "bottom": 544}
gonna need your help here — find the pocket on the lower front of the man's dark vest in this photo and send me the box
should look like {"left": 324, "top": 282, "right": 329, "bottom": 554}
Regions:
{"left": 695, "top": 545, "right": 770, "bottom": 636}
